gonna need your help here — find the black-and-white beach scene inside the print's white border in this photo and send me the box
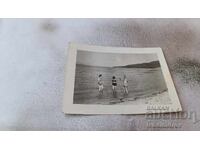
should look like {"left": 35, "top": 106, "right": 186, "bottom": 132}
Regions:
{"left": 73, "top": 50, "right": 170, "bottom": 105}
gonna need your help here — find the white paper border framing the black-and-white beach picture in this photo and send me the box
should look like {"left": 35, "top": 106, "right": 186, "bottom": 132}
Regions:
{"left": 63, "top": 43, "right": 182, "bottom": 114}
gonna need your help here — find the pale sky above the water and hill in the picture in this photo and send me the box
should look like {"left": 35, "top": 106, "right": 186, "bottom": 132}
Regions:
{"left": 76, "top": 51, "right": 158, "bottom": 67}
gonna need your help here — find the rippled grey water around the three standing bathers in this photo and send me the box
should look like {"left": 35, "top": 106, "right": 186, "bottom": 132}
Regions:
{"left": 74, "top": 65, "right": 167, "bottom": 104}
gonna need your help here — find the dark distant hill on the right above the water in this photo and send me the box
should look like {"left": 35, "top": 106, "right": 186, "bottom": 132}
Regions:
{"left": 115, "top": 61, "right": 160, "bottom": 68}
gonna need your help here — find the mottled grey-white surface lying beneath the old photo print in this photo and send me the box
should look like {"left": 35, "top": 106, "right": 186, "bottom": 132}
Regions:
{"left": 0, "top": 19, "right": 200, "bottom": 130}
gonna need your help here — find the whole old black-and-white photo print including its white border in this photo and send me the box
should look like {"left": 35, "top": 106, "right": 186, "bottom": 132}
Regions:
{"left": 63, "top": 43, "right": 182, "bottom": 114}
